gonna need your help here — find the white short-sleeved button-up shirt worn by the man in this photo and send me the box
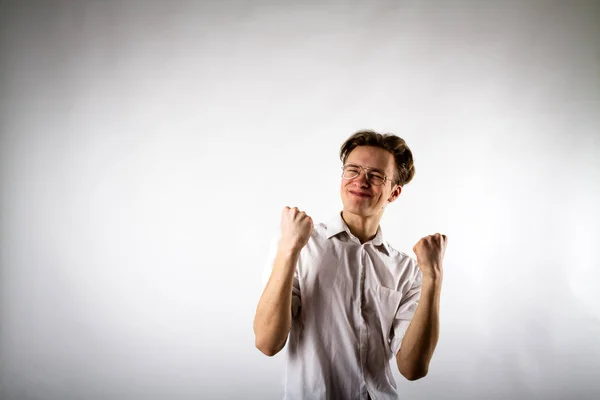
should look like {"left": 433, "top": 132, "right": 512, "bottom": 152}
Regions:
{"left": 264, "top": 213, "right": 422, "bottom": 400}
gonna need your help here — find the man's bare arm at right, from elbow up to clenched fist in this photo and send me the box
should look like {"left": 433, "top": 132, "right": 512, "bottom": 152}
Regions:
{"left": 396, "top": 233, "right": 447, "bottom": 381}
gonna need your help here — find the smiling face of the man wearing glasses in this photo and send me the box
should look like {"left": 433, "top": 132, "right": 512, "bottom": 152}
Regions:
{"left": 340, "top": 146, "right": 401, "bottom": 217}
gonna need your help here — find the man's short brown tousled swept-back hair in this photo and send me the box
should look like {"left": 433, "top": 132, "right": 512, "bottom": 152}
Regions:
{"left": 340, "top": 129, "right": 415, "bottom": 186}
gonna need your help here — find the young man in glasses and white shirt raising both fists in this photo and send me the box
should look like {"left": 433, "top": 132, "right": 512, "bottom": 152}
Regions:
{"left": 254, "top": 131, "right": 447, "bottom": 400}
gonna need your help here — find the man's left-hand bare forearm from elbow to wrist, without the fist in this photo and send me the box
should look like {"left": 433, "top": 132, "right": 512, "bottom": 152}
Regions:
{"left": 254, "top": 249, "right": 300, "bottom": 356}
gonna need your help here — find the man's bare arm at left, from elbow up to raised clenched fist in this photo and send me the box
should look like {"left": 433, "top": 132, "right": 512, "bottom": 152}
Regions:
{"left": 254, "top": 207, "right": 313, "bottom": 357}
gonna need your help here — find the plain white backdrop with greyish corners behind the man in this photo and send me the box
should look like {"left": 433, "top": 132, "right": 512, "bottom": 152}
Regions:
{"left": 0, "top": 0, "right": 600, "bottom": 400}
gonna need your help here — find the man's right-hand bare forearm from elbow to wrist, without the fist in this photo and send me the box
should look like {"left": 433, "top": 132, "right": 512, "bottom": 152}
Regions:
{"left": 396, "top": 276, "right": 442, "bottom": 380}
